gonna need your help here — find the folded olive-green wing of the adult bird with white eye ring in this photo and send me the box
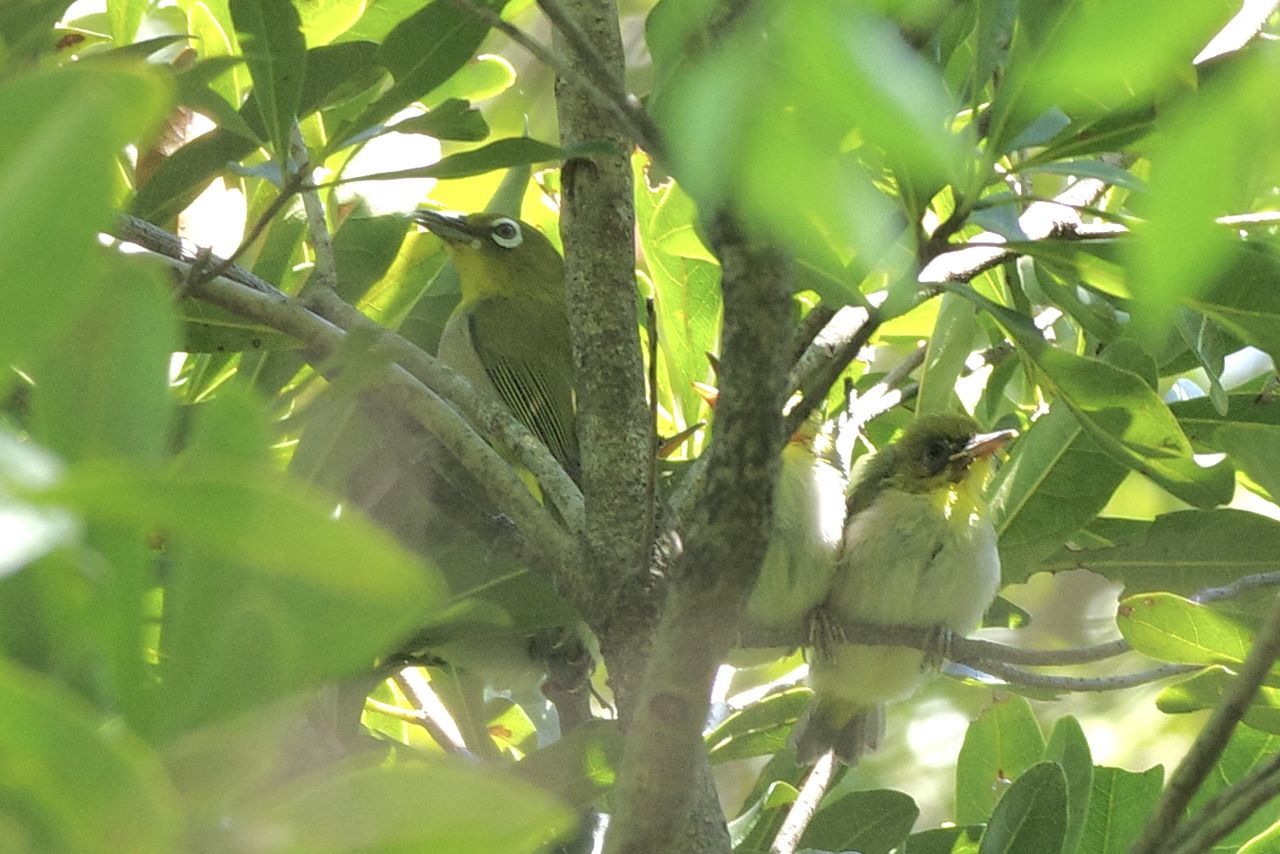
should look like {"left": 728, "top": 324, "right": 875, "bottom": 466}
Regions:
{"left": 470, "top": 298, "right": 580, "bottom": 480}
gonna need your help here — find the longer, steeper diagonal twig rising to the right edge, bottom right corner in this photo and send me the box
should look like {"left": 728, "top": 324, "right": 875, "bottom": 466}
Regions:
{"left": 1130, "top": 595, "right": 1280, "bottom": 854}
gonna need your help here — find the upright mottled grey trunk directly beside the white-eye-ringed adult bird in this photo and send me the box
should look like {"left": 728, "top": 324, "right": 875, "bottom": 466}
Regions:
{"left": 556, "top": 0, "right": 654, "bottom": 617}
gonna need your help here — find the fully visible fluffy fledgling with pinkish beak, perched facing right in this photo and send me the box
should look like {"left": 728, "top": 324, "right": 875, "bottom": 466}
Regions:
{"left": 794, "top": 415, "right": 1012, "bottom": 764}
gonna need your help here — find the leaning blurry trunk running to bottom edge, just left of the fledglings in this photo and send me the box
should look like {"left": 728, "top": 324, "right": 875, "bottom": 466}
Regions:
{"left": 605, "top": 216, "right": 791, "bottom": 854}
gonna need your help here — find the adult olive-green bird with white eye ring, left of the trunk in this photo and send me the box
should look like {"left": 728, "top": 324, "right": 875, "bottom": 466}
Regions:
{"left": 411, "top": 209, "right": 579, "bottom": 479}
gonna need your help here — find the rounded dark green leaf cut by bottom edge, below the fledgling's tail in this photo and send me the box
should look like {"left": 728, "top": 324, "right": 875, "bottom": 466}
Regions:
{"left": 800, "top": 789, "right": 920, "bottom": 854}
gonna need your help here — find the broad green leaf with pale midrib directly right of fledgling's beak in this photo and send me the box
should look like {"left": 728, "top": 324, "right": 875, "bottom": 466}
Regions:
{"left": 991, "top": 402, "right": 1128, "bottom": 584}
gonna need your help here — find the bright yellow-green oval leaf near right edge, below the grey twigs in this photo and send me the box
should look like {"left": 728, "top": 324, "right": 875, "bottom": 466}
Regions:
{"left": 1116, "top": 593, "right": 1253, "bottom": 665}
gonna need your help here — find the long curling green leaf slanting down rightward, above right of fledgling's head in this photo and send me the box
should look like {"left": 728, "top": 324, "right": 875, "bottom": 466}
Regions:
{"left": 955, "top": 288, "right": 1235, "bottom": 507}
